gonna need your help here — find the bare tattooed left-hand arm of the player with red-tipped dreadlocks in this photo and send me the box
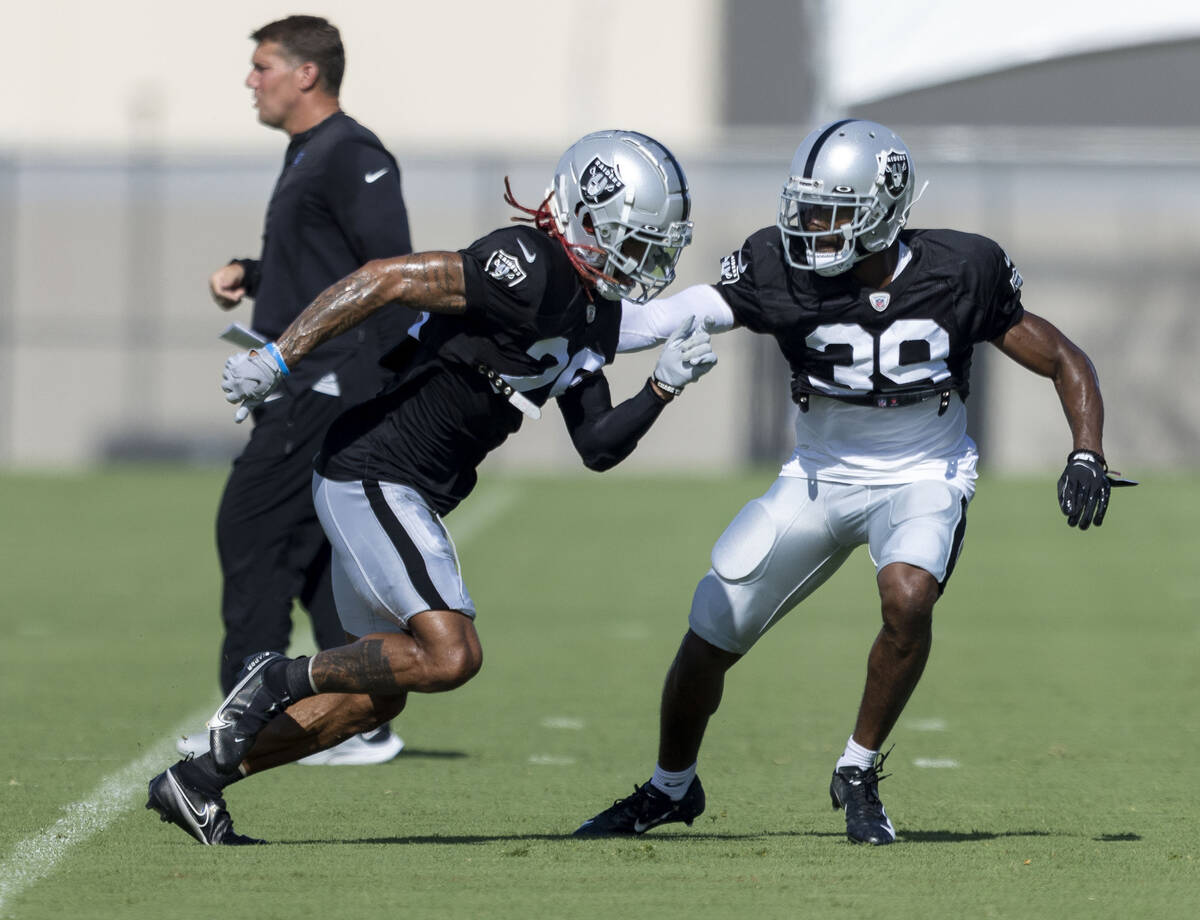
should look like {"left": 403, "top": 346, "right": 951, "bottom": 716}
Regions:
{"left": 276, "top": 252, "right": 467, "bottom": 367}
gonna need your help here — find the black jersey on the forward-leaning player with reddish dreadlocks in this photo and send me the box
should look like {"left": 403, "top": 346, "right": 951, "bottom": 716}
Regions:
{"left": 317, "top": 227, "right": 620, "bottom": 515}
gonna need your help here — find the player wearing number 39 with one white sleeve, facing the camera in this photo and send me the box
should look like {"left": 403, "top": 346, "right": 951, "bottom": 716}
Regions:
{"left": 575, "top": 120, "right": 1116, "bottom": 844}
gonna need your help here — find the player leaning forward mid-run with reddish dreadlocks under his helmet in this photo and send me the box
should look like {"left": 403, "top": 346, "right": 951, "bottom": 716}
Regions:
{"left": 146, "top": 131, "right": 716, "bottom": 844}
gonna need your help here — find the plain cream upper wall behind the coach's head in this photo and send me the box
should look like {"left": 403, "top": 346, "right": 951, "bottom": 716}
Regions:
{"left": 0, "top": 0, "right": 720, "bottom": 151}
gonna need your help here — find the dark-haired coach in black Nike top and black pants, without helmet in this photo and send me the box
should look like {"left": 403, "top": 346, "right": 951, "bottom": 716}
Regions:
{"left": 180, "top": 16, "right": 415, "bottom": 764}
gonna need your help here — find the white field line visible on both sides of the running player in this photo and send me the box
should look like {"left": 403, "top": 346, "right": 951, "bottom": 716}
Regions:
{"left": 0, "top": 488, "right": 518, "bottom": 916}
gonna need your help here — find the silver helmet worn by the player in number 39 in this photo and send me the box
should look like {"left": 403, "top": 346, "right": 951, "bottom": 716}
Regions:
{"left": 778, "top": 119, "right": 917, "bottom": 275}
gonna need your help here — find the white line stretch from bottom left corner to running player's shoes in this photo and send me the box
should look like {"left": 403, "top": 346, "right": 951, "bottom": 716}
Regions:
{"left": 0, "top": 710, "right": 209, "bottom": 916}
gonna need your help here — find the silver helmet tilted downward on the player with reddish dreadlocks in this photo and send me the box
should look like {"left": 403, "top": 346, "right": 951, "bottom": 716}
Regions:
{"left": 548, "top": 131, "right": 691, "bottom": 303}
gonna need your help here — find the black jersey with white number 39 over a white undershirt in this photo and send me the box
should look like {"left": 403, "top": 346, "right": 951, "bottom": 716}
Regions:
{"left": 714, "top": 227, "right": 1024, "bottom": 405}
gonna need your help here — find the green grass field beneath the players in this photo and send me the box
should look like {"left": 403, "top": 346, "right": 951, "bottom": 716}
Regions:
{"left": 0, "top": 468, "right": 1200, "bottom": 920}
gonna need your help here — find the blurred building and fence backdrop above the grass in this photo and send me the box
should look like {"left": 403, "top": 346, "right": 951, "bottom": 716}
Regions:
{"left": 0, "top": 0, "right": 1200, "bottom": 470}
